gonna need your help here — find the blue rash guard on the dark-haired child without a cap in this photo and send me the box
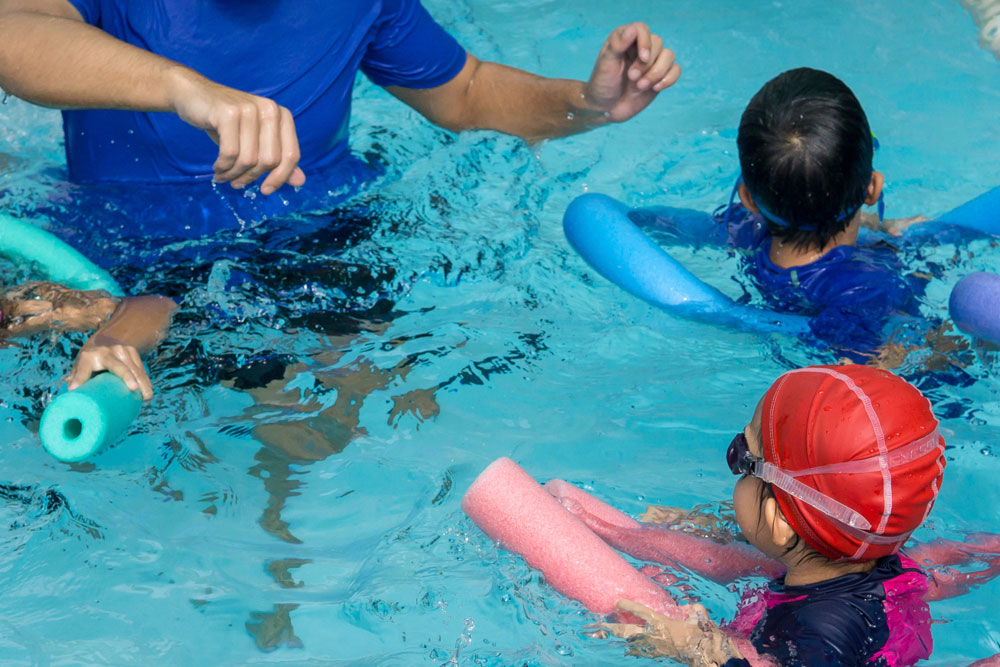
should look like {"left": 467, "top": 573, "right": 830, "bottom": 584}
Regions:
{"left": 716, "top": 204, "right": 923, "bottom": 361}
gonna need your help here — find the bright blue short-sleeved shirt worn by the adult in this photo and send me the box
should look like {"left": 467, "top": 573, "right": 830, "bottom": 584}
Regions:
{"left": 63, "top": 0, "right": 465, "bottom": 183}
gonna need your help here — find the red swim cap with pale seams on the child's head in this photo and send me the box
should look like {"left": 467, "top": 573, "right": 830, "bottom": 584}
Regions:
{"left": 761, "top": 366, "right": 945, "bottom": 560}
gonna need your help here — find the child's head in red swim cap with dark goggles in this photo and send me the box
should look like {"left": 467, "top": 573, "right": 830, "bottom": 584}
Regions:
{"left": 728, "top": 366, "right": 945, "bottom": 561}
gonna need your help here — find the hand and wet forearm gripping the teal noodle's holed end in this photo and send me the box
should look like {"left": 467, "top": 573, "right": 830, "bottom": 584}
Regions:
{"left": 67, "top": 296, "right": 177, "bottom": 401}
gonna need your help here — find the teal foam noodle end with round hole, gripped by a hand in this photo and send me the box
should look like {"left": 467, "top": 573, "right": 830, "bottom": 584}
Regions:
{"left": 38, "top": 373, "right": 142, "bottom": 461}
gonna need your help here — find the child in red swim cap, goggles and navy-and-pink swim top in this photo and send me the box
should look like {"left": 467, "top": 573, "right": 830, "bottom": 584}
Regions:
{"left": 615, "top": 366, "right": 945, "bottom": 667}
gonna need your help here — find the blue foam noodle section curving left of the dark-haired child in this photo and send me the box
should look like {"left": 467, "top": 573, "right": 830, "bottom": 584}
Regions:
{"left": 563, "top": 194, "right": 809, "bottom": 335}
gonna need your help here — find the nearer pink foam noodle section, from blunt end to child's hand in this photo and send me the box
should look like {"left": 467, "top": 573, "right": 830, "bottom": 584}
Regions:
{"left": 462, "top": 458, "right": 684, "bottom": 618}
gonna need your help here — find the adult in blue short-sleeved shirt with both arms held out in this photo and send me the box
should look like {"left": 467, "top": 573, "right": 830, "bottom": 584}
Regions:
{"left": 0, "top": 0, "right": 681, "bottom": 194}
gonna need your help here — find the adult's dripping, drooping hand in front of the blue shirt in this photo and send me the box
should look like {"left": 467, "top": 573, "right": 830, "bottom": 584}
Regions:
{"left": 168, "top": 69, "right": 306, "bottom": 195}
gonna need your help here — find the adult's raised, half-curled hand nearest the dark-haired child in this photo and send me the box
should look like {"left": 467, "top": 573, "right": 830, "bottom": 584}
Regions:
{"left": 584, "top": 22, "right": 681, "bottom": 123}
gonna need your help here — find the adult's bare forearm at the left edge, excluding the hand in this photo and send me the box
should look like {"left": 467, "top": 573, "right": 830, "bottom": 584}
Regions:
{"left": 0, "top": 11, "right": 186, "bottom": 111}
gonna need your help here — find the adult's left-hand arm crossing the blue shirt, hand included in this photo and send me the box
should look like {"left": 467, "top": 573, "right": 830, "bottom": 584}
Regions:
{"left": 0, "top": 0, "right": 305, "bottom": 194}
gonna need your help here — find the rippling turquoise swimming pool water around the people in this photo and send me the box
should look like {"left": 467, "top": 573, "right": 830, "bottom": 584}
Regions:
{"left": 0, "top": 0, "right": 1000, "bottom": 665}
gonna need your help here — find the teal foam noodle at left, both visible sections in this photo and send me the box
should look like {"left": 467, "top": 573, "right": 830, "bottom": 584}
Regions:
{"left": 0, "top": 214, "right": 142, "bottom": 461}
